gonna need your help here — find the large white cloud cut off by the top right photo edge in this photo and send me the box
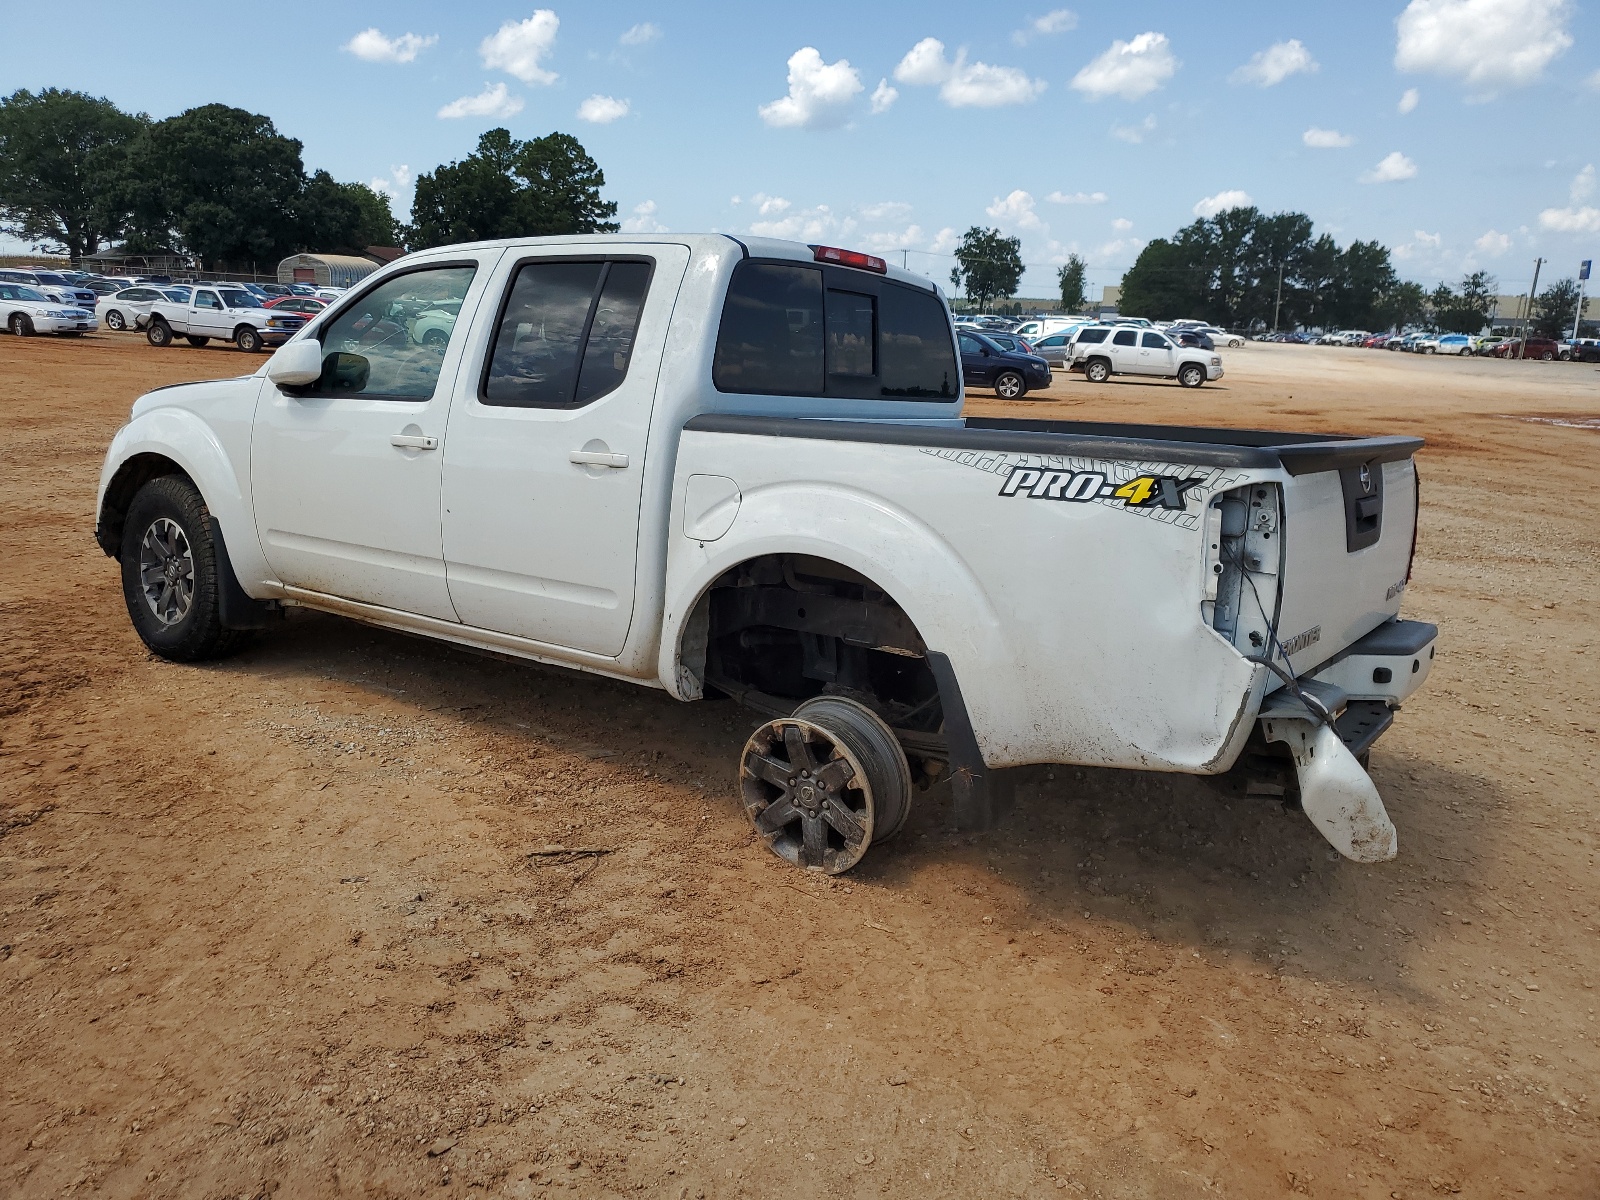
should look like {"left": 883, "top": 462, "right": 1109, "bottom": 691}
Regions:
{"left": 1395, "top": 0, "right": 1573, "bottom": 96}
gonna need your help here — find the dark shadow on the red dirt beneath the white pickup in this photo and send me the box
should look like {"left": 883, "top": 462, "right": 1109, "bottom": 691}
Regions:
{"left": 208, "top": 613, "right": 1491, "bottom": 992}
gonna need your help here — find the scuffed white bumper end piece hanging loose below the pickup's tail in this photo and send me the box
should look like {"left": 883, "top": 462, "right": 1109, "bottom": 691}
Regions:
{"left": 1261, "top": 717, "right": 1397, "bottom": 862}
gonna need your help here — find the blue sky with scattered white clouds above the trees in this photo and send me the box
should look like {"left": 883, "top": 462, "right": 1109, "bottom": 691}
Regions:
{"left": 0, "top": 0, "right": 1600, "bottom": 296}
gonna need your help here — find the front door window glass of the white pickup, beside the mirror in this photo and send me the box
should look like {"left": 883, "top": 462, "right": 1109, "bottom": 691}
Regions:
{"left": 309, "top": 266, "right": 477, "bottom": 400}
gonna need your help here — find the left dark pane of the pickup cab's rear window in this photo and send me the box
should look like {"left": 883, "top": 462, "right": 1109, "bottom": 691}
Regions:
{"left": 712, "top": 262, "right": 822, "bottom": 395}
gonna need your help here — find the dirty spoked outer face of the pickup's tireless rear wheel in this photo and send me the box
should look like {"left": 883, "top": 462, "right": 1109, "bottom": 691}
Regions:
{"left": 739, "top": 717, "right": 874, "bottom": 875}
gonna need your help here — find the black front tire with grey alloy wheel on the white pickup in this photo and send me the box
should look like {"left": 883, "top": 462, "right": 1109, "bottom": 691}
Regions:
{"left": 118, "top": 475, "right": 248, "bottom": 662}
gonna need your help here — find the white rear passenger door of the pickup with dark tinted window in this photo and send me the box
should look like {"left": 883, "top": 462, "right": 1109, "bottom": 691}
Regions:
{"left": 445, "top": 245, "right": 688, "bottom": 656}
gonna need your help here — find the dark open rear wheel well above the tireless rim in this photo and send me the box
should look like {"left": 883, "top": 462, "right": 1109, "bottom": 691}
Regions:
{"left": 678, "top": 554, "right": 947, "bottom": 784}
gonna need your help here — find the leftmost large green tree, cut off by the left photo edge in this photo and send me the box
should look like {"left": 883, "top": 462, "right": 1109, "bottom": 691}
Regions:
{"left": 0, "top": 88, "right": 149, "bottom": 259}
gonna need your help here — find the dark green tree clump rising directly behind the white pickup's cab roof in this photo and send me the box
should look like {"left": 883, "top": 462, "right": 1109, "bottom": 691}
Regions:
{"left": 408, "top": 130, "right": 618, "bottom": 250}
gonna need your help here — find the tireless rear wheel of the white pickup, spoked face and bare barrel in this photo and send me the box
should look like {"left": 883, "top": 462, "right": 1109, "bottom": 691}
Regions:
{"left": 739, "top": 698, "right": 910, "bottom": 875}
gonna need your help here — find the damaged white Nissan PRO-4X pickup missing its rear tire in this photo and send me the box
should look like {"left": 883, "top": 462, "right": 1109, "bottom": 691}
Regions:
{"left": 96, "top": 235, "right": 1437, "bottom": 872}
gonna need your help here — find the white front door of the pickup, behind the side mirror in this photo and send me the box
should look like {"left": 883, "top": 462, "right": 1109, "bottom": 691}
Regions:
{"left": 250, "top": 259, "right": 501, "bottom": 621}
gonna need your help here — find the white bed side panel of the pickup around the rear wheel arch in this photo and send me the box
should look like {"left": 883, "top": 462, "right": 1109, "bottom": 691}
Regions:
{"left": 661, "top": 432, "right": 1262, "bottom": 771}
